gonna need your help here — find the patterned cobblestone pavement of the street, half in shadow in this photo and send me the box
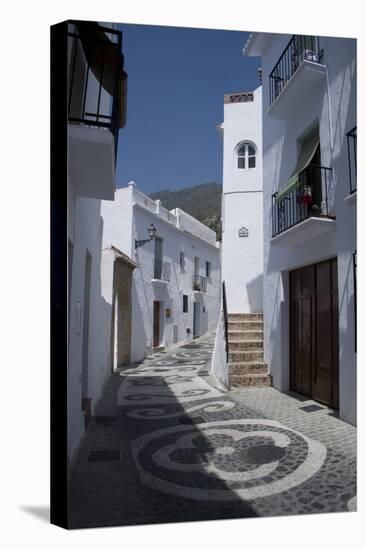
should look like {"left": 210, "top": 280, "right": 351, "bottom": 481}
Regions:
{"left": 69, "top": 336, "right": 356, "bottom": 528}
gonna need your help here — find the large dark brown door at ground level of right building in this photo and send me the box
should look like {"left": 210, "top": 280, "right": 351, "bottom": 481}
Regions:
{"left": 290, "top": 259, "right": 339, "bottom": 408}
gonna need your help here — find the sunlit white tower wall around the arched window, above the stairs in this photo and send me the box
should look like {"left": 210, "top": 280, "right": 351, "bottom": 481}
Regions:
{"left": 221, "top": 87, "right": 263, "bottom": 313}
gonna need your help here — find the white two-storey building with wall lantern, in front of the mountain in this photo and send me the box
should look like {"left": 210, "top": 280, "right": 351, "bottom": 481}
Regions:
{"left": 102, "top": 182, "right": 221, "bottom": 368}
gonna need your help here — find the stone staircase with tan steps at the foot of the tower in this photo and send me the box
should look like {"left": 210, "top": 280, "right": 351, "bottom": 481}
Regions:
{"left": 228, "top": 313, "right": 272, "bottom": 387}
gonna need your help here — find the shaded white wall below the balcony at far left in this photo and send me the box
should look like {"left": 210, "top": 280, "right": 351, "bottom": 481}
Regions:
{"left": 68, "top": 181, "right": 111, "bottom": 459}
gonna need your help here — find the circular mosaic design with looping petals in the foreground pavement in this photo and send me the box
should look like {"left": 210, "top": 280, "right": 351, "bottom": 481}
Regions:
{"left": 132, "top": 419, "right": 326, "bottom": 500}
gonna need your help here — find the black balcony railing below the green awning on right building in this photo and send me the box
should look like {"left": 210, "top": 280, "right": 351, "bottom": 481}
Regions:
{"left": 272, "top": 164, "right": 332, "bottom": 237}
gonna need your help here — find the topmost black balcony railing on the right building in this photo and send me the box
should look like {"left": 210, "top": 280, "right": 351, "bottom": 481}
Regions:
{"left": 269, "top": 34, "right": 323, "bottom": 105}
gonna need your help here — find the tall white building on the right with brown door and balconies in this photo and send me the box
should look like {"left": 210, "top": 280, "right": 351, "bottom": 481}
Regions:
{"left": 244, "top": 33, "right": 357, "bottom": 424}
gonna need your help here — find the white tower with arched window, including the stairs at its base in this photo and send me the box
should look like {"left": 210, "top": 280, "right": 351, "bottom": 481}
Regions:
{"left": 211, "top": 86, "right": 271, "bottom": 387}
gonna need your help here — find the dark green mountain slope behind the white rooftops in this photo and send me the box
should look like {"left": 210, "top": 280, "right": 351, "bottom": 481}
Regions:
{"left": 150, "top": 182, "right": 222, "bottom": 241}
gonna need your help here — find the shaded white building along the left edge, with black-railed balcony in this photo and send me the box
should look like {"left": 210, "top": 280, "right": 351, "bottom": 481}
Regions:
{"left": 67, "top": 22, "right": 127, "bottom": 460}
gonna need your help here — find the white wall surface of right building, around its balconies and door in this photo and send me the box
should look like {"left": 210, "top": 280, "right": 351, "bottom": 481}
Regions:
{"left": 253, "top": 35, "right": 356, "bottom": 424}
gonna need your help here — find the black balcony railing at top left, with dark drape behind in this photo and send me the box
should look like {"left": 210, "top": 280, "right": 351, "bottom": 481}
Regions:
{"left": 68, "top": 22, "right": 127, "bottom": 155}
